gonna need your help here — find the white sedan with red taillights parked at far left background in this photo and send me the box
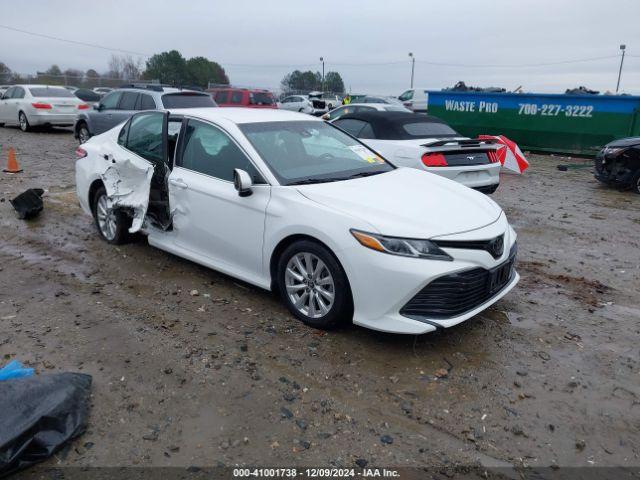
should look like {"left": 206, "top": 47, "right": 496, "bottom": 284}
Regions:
{"left": 0, "top": 85, "right": 89, "bottom": 132}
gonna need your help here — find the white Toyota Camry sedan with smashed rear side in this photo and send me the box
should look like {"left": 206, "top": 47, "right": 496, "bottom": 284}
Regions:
{"left": 76, "top": 108, "right": 519, "bottom": 334}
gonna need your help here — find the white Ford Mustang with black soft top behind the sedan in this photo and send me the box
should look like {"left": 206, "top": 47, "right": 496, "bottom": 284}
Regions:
{"left": 332, "top": 111, "right": 501, "bottom": 193}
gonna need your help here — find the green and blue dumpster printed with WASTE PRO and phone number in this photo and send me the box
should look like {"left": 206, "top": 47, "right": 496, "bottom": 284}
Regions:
{"left": 425, "top": 91, "right": 640, "bottom": 155}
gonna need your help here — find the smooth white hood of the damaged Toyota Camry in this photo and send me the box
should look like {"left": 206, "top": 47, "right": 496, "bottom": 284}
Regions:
{"left": 296, "top": 168, "right": 502, "bottom": 238}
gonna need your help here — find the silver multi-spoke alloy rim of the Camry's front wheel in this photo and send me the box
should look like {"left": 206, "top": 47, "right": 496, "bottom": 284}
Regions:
{"left": 284, "top": 252, "right": 336, "bottom": 318}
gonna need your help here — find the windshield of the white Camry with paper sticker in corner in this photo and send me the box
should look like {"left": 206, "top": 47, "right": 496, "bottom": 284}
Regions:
{"left": 239, "top": 120, "right": 394, "bottom": 185}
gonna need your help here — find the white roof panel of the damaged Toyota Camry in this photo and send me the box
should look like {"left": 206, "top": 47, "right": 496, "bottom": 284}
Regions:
{"left": 171, "top": 107, "right": 322, "bottom": 124}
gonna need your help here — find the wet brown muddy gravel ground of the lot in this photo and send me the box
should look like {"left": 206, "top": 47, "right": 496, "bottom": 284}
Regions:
{"left": 0, "top": 128, "right": 640, "bottom": 474}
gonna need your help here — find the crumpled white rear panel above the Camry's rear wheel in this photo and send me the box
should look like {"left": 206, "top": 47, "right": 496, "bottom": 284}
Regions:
{"left": 100, "top": 157, "right": 154, "bottom": 233}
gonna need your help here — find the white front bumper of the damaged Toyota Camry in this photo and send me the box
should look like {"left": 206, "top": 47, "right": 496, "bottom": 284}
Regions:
{"left": 340, "top": 214, "right": 520, "bottom": 335}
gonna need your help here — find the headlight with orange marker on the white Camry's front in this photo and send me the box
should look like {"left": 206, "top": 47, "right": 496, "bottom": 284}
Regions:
{"left": 350, "top": 229, "right": 453, "bottom": 261}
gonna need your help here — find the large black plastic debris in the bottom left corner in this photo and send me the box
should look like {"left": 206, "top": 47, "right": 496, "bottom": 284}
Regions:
{"left": 0, "top": 373, "right": 91, "bottom": 477}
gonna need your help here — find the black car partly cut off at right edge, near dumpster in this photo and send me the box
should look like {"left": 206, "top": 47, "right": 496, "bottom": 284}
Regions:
{"left": 594, "top": 137, "right": 640, "bottom": 193}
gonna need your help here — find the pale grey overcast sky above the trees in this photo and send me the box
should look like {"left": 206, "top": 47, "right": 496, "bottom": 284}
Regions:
{"left": 0, "top": 0, "right": 640, "bottom": 95}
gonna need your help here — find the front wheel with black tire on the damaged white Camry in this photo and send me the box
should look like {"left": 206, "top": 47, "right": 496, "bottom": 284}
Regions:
{"left": 277, "top": 240, "right": 353, "bottom": 329}
